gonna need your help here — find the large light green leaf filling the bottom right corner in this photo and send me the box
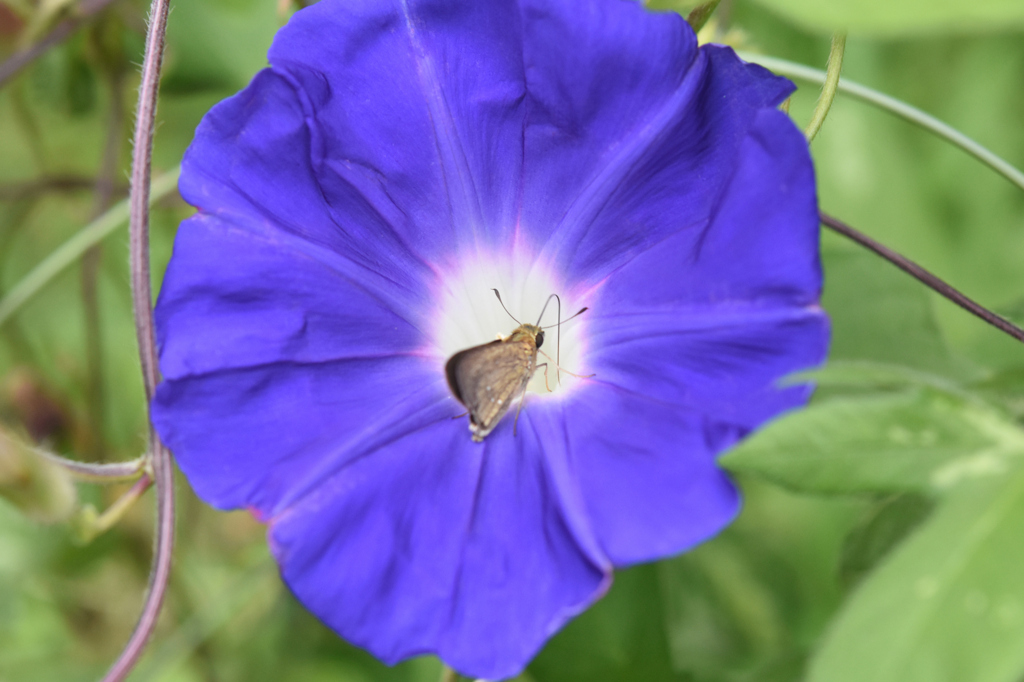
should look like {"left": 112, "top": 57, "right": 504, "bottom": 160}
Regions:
{"left": 808, "top": 472, "right": 1024, "bottom": 682}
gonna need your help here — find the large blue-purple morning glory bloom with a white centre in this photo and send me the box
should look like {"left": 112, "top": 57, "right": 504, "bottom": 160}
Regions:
{"left": 154, "top": 0, "right": 827, "bottom": 679}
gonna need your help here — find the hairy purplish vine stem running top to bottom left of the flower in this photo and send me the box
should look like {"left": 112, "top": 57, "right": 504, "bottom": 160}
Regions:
{"left": 103, "top": 0, "right": 174, "bottom": 682}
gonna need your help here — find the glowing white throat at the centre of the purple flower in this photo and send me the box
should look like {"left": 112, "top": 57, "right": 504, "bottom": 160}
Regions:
{"left": 433, "top": 245, "right": 588, "bottom": 395}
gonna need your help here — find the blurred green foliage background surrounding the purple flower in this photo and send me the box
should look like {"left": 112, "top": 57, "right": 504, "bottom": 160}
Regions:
{"left": 0, "top": 0, "right": 1024, "bottom": 682}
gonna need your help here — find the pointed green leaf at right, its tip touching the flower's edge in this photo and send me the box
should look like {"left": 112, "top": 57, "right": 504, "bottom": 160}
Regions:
{"left": 721, "top": 388, "right": 1024, "bottom": 493}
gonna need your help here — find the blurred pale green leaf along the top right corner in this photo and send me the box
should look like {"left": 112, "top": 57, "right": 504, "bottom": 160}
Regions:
{"left": 745, "top": 0, "right": 1024, "bottom": 36}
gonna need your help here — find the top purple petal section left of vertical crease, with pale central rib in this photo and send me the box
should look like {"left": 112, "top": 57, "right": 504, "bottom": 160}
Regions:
{"left": 269, "top": 0, "right": 523, "bottom": 265}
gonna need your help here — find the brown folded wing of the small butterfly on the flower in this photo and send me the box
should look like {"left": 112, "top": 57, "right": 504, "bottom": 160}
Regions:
{"left": 444, "top": 339, "right": 537, "bottom": 440}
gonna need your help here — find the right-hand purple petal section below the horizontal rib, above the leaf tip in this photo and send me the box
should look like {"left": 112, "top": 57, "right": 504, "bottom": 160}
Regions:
{"left": 588, "top": 305, "right": 828, "bottom": 430}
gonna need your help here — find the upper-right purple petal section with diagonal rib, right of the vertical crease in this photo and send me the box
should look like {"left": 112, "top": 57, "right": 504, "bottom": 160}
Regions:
{"left": 521, "top": 5, "right": 793, "bottom": 283}
